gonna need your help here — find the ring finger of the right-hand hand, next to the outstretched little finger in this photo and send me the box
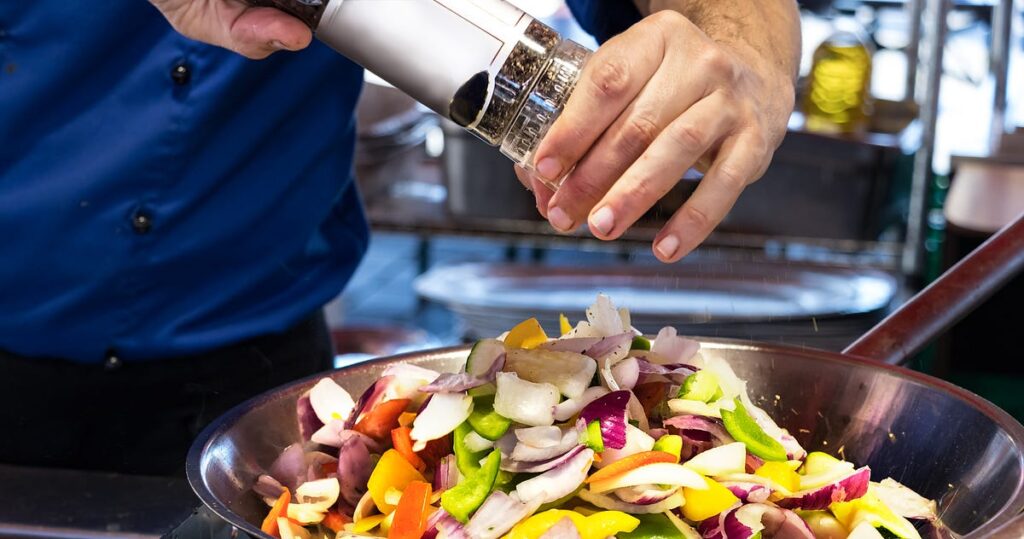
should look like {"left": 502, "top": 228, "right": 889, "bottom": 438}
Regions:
{"left": 585, "top": 92, "right": 736, "bottom": 240}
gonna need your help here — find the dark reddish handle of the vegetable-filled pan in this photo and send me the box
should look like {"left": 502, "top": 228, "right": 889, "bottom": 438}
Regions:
{"left": 843, "top": 214, "right": 1024, "bottom": 365}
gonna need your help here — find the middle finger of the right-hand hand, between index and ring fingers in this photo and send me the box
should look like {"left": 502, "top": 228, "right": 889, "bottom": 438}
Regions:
{"left": 548, "top": 60, "right": 721, "bottom": 232}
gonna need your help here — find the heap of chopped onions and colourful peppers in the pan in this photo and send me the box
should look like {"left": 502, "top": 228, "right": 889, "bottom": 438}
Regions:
{"left": 253, "top": 296, "right": 941, "bottom": 539}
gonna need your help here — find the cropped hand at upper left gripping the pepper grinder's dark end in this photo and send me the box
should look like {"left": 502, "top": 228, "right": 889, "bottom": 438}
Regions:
{"left": 150, "top": 0, "right": 312, "bottom": 59}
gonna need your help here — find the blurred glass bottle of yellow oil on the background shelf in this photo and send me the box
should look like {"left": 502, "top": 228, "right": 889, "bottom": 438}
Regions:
{"left": 803, "top": 16, "right": 873, "bottom": 133}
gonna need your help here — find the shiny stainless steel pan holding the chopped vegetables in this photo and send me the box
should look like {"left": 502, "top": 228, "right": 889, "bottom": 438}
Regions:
{"left": 187, "top": 339, "right": 1024, "bottom": 538}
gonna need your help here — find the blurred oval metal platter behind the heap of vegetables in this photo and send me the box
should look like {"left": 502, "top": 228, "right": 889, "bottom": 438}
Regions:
{"left": 415, "top": 259, "right": 897, "bottom": 350}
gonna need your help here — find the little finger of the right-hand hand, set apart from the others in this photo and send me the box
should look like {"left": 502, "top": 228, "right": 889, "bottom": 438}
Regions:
{"left": 653, "top": 132, "right": 770, "bottom": 262}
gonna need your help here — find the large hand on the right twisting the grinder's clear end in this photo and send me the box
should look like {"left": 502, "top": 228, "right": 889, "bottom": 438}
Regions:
{"left": 516, "top": 10, "right": 799, "bottom": 262}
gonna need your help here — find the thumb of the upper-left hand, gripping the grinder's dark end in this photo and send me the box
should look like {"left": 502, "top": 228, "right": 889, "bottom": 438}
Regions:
{"left": 226, "top": 7, "right": 312, "bottom": 59}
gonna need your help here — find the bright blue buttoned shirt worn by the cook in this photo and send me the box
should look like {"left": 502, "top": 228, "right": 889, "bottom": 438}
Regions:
{"left": 0, "top": 0, "right": 635, "bottom": 362}
